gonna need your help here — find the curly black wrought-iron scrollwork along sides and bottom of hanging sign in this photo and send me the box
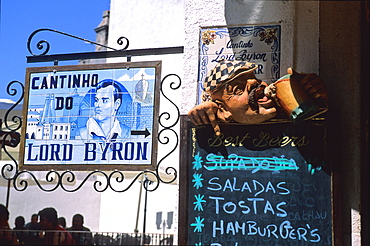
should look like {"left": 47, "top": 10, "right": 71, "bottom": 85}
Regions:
{"left": 1, "top": 74, "right": 181, "bottom": 192}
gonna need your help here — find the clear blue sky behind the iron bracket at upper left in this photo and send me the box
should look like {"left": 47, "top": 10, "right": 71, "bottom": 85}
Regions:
{"left": 0, "top": 0, "right": 110, "bottom": 101}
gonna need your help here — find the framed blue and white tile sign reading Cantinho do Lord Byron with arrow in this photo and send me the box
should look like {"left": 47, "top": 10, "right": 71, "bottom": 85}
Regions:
{"left": 21, "top": 61, "right": 161, "bottom": 170}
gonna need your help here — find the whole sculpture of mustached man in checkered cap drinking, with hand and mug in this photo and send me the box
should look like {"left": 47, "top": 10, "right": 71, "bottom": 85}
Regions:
{"left": 188, "top": 60, "right": 327, "bottom": 135}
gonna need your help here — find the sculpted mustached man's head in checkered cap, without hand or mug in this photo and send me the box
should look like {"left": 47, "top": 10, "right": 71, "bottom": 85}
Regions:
{"left": 204, "top": 60, "right": 276, "bottom": 124}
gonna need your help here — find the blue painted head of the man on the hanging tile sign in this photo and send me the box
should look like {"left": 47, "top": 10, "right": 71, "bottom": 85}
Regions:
{"left": 94, "top": 85, "right": 121, "bottom": 121}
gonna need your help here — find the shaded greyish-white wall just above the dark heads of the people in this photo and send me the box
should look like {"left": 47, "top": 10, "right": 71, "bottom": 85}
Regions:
{"left": 0, "top": 166, "right": 101, "bottom": 231}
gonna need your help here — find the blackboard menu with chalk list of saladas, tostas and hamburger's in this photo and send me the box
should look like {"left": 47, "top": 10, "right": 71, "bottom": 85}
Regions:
{"left": 179, "top": 118, "right": 332, "bottom": 246}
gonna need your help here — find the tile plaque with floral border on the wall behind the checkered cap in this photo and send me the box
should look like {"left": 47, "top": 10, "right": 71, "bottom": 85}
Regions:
{"left": 198, "top": 25, "right": 281, "bottom": 103}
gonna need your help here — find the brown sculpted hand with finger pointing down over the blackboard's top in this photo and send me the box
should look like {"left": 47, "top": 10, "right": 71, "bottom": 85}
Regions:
{"left": 188, "top": 101, "right": 229, "bottom": 136}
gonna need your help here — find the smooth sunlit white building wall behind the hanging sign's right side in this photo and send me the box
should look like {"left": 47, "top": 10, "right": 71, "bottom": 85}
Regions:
{"left": 100, "top": 0, "right": 186, "bottom": 236}
